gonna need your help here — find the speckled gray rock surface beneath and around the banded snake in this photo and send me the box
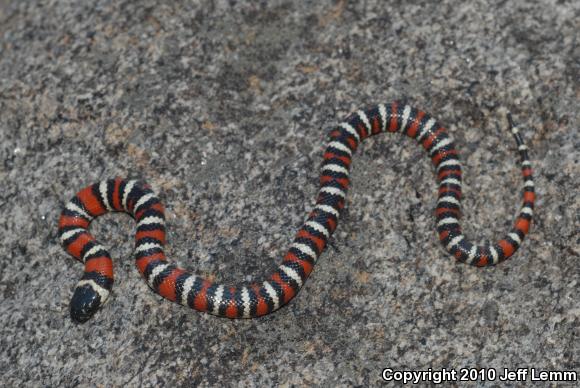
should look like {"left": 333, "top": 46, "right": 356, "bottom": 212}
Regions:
{"left": 0, "top": 0, "right": 580, "bottom": 386}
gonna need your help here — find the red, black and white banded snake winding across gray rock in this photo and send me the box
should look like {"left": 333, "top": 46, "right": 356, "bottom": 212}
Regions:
{"left": 58, "top": 101, "right": 535, "bottom": 323}
